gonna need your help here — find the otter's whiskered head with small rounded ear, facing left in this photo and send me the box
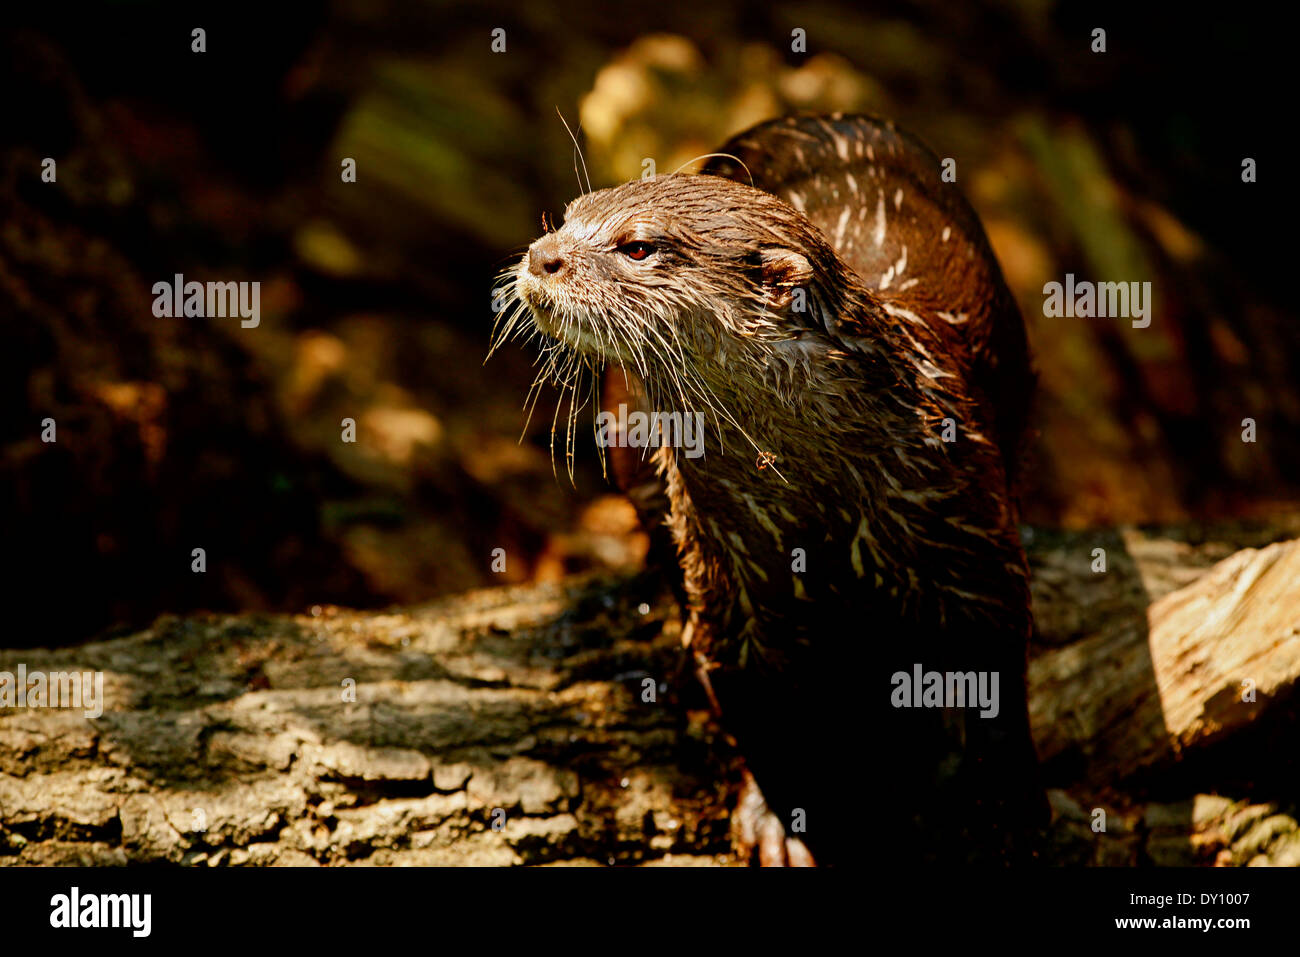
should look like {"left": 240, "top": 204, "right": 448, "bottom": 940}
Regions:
{"left": 514, "top": 174, "right": 852, "bottom": 377}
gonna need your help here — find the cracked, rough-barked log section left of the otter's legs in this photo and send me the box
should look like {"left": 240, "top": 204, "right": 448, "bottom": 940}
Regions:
{"left": 0, "top": 579, "right": 731, "bottom": 865}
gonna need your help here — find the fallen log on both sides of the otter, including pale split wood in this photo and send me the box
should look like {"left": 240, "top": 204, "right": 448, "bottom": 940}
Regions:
{"left": 0, "top": 532, "right": 1300, "bottom": 865}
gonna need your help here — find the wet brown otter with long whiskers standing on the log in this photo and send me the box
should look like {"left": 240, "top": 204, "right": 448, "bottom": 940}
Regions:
{"left": 498, "top": 116, "right": 1045, "bottom": 863}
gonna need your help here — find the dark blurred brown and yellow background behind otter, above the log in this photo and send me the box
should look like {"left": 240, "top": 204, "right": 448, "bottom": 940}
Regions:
{"left": 0, "top": 0, "right": 1300, "bottom": 645}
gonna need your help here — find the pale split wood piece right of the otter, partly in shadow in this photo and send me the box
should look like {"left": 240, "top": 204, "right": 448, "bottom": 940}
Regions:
{"left": 1030, "top": 540, "right": 1300, "bottom": 781}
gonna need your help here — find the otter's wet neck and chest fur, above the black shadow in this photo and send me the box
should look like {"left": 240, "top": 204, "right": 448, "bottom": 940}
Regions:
{"left": 660, "top": 291, "right": 1027, "bottom": 663}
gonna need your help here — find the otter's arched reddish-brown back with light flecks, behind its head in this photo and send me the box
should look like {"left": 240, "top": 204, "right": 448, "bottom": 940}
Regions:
{"left": 703, "top": 114, "right": 1034, "bottom": 482}
